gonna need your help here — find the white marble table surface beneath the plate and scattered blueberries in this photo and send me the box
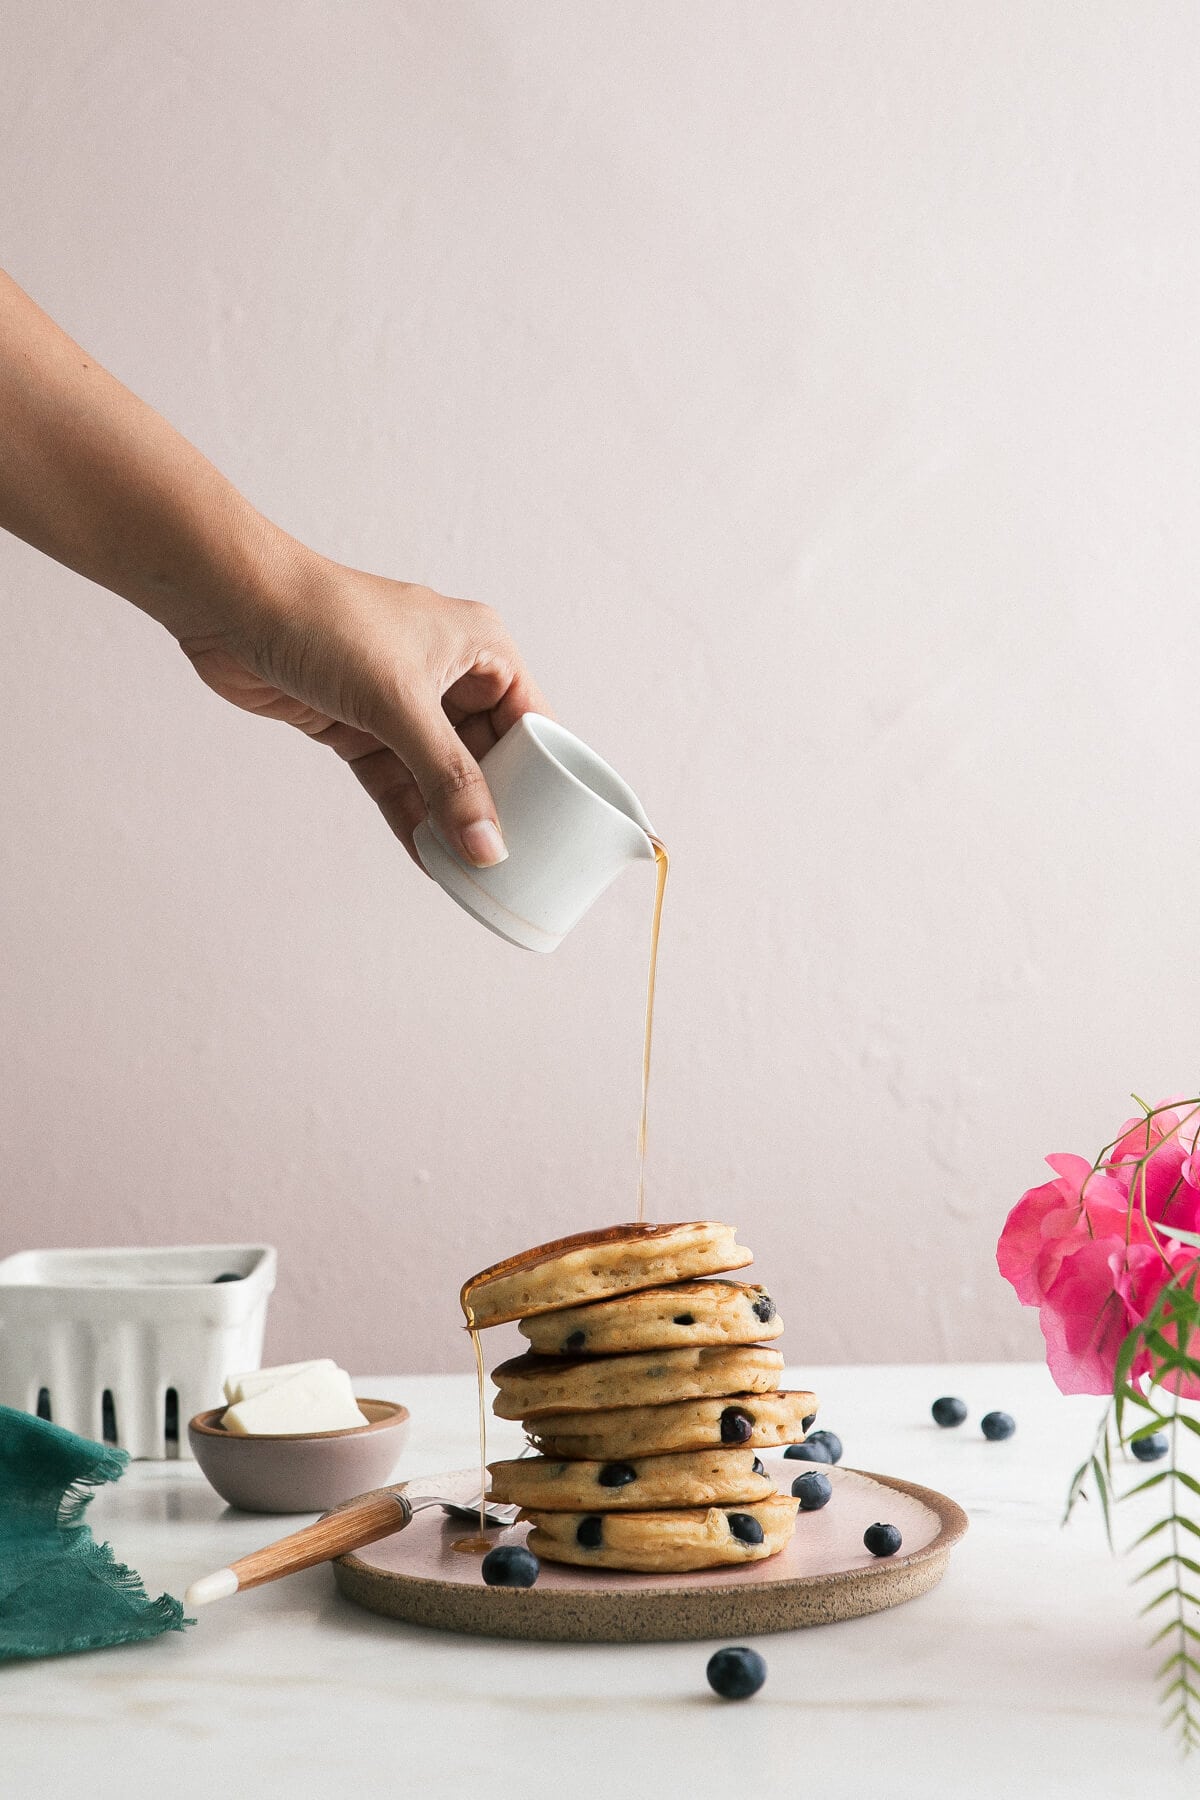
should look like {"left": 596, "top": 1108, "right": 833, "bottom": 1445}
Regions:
{"left": 0, "top": 1364, "right": 1200, "bottom": 1800}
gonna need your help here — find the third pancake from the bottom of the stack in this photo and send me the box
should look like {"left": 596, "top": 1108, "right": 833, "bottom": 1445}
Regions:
{"left": 527, "top": 1391, "right": 817, "bottom": 1462}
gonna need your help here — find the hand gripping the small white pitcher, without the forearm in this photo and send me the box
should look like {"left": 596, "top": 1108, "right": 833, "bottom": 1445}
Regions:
{"left": 180, "top": 545, "right": 545, "bottom": 868}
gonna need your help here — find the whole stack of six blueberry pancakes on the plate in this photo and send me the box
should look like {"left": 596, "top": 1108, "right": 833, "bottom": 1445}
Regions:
{"left": 462, "top": 1222, "right": 817, "bottom": 1571}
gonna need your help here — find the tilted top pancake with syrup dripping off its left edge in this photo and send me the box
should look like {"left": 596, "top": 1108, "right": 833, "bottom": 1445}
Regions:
{"left": 461, "top": 1220, "right": 754, "bottom": 1328}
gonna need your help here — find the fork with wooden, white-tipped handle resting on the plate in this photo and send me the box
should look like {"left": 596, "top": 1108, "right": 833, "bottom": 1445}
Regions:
{"left": 184, "top": 1487, "right": 520, "bottom": 1606}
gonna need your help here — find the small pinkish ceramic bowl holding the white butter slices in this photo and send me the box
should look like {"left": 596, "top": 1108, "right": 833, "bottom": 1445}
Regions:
{"left": 187, "top": 1399, "right": 408, "bottom": 1512}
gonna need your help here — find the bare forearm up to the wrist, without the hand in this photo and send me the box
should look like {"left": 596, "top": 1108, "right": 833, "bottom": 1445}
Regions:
{"left": 0, "top": 272, "right": 309, "bottom": 637}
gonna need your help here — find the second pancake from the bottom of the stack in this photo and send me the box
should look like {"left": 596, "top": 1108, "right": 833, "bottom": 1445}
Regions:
{"left": 488, "top": 1449, "right": 775, "bottom": 1512}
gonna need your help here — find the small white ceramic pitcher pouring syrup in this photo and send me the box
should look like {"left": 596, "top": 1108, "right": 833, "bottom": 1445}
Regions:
{"left": 414, "top": 713, "right": 655, "bottom": 950}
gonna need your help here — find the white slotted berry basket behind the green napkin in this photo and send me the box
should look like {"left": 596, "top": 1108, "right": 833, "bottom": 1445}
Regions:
{"left": 0, "top": 1244, "right": 275, "bottom": 1458}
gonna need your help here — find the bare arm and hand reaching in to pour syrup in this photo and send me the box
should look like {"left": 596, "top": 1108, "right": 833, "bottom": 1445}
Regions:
{"left": 0, "top": 272, "right": 545, "bottom": 868}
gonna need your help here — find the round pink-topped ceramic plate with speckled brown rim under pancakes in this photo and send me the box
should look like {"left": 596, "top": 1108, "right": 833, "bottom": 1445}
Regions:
{"left": 333, "top": 1456, "right": 966, "bottom": 1643}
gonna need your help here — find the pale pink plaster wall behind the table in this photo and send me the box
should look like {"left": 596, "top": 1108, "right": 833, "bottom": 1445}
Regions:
{"left": 0, "top": 0, "right": 1200, "bottom": 1370}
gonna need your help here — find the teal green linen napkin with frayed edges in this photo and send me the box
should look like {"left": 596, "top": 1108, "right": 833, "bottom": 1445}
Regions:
{"left": 0, "top": 1406, "right": 185, "bottom": 1661}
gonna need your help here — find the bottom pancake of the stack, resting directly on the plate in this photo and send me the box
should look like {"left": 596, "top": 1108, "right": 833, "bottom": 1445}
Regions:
{"left": 522, "top": 1494, "right": 797, "bottom": 1575}
